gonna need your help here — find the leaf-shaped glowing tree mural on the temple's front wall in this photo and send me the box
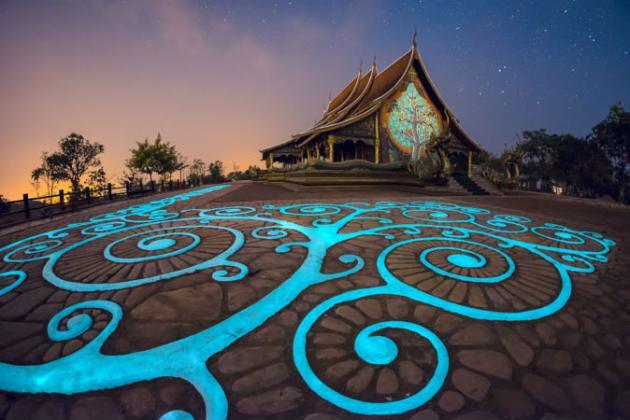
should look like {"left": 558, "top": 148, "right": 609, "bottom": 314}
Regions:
{"left": 387, "top": 83, "right": 440, "bottom": 161}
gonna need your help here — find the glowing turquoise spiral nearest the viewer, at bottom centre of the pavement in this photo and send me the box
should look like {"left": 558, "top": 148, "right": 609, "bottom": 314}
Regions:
{"left": 293, "top": 291, "right": 448, "bottom": 415}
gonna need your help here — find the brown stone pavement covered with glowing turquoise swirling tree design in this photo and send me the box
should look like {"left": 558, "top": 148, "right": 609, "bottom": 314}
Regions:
{"left": 0, "top": 185, "right": 630, "bottom": 420}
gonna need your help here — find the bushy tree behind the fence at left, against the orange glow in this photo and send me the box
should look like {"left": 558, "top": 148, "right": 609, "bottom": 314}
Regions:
{"left": 46, "top": 133, "right": 105, "bottom": 197}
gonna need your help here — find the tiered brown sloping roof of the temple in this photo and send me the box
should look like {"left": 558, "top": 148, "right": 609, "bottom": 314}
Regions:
{"left": 261, "top": 41, "right": 482, "bottom": 153}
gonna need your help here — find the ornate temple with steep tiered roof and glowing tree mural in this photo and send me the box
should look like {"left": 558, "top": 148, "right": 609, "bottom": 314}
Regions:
{"left": 261, "top": 35, "right": 494, "bottom": 192}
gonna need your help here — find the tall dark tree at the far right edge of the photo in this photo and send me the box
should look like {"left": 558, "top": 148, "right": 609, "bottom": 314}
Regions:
{"left": 591, "top": 103, "right": 630, "bottom": 203}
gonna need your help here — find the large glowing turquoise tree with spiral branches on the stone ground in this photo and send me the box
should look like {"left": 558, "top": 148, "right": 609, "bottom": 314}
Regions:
{"left": 0, "top": 185, "right": 614, "bottom": 419}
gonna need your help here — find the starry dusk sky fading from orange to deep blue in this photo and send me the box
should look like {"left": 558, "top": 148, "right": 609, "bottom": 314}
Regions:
{"left": 0, "top": 0, "right": 630, "bottom": 198}
